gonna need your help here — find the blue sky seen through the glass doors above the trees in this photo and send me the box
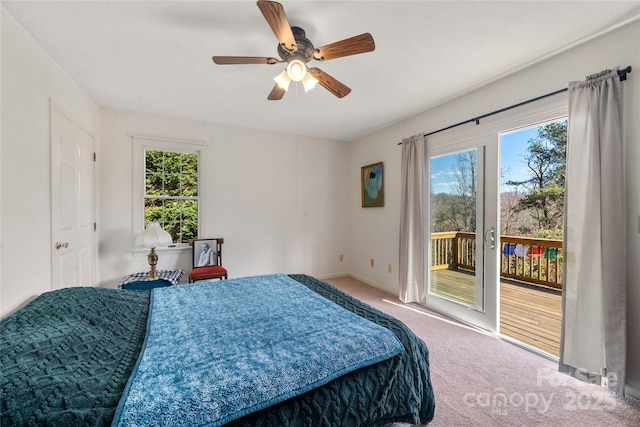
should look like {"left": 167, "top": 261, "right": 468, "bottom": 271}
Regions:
{"left": 431, "top": 127, "right": 537, "bottom": 193}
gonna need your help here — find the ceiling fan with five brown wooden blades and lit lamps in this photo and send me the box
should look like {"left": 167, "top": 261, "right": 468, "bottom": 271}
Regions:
{"left": 213, "top": 0, "right": 375, "bottom": 101}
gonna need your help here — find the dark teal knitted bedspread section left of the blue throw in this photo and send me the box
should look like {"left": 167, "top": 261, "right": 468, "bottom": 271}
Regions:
{"left": 0, "top": 287, "right": 149, "bottom": 427}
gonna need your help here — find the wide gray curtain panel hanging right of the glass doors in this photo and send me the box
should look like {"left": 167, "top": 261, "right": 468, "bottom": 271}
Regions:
{"left": 560, "top": 68, "right": 627, "bottom": 396}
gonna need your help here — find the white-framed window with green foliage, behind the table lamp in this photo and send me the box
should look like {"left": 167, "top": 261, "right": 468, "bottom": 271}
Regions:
{"left": 133, "top": 138, "right": 205, "bottom": 245}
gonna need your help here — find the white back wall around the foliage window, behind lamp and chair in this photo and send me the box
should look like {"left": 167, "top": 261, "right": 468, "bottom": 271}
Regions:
{"left": 99, "top": 109, "right": 349, "bottom": 287}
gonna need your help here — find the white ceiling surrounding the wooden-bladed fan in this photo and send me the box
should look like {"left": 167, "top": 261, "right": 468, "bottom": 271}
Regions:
{"left": 2, "top": 0, "right": 640, "bottom": 141}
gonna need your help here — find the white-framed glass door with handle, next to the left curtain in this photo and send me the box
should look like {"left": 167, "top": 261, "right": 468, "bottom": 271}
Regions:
{"left": 425, "top": 135, "right": 499, "bottom": 331}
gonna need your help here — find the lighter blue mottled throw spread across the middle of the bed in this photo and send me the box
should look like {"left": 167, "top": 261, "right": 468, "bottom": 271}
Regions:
{"left": 113, "top": 275, "right": 404, "bottom": 426}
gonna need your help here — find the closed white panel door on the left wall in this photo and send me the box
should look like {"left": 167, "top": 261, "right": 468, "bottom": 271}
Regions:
{"left": 51, "top": 102, "right": 96, "bottom": 289}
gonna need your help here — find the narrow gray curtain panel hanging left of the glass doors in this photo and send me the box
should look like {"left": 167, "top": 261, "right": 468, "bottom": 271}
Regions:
{"left": 398, "top": 135, "right": 426, "bottom": 302}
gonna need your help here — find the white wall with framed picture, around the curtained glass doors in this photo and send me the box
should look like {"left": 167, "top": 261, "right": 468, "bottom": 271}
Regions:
{"left": 349, "top": 21, "right": 640, "bottom": 394}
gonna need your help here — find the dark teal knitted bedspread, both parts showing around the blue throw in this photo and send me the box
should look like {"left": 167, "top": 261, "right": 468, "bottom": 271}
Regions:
{"left": 0, "top": 274, "right": 435, "bottom": 427}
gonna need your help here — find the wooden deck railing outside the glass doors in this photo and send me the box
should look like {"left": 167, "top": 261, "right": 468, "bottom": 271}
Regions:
{"left": 431, "top": 231, "right": 562, "bottom": 289}
